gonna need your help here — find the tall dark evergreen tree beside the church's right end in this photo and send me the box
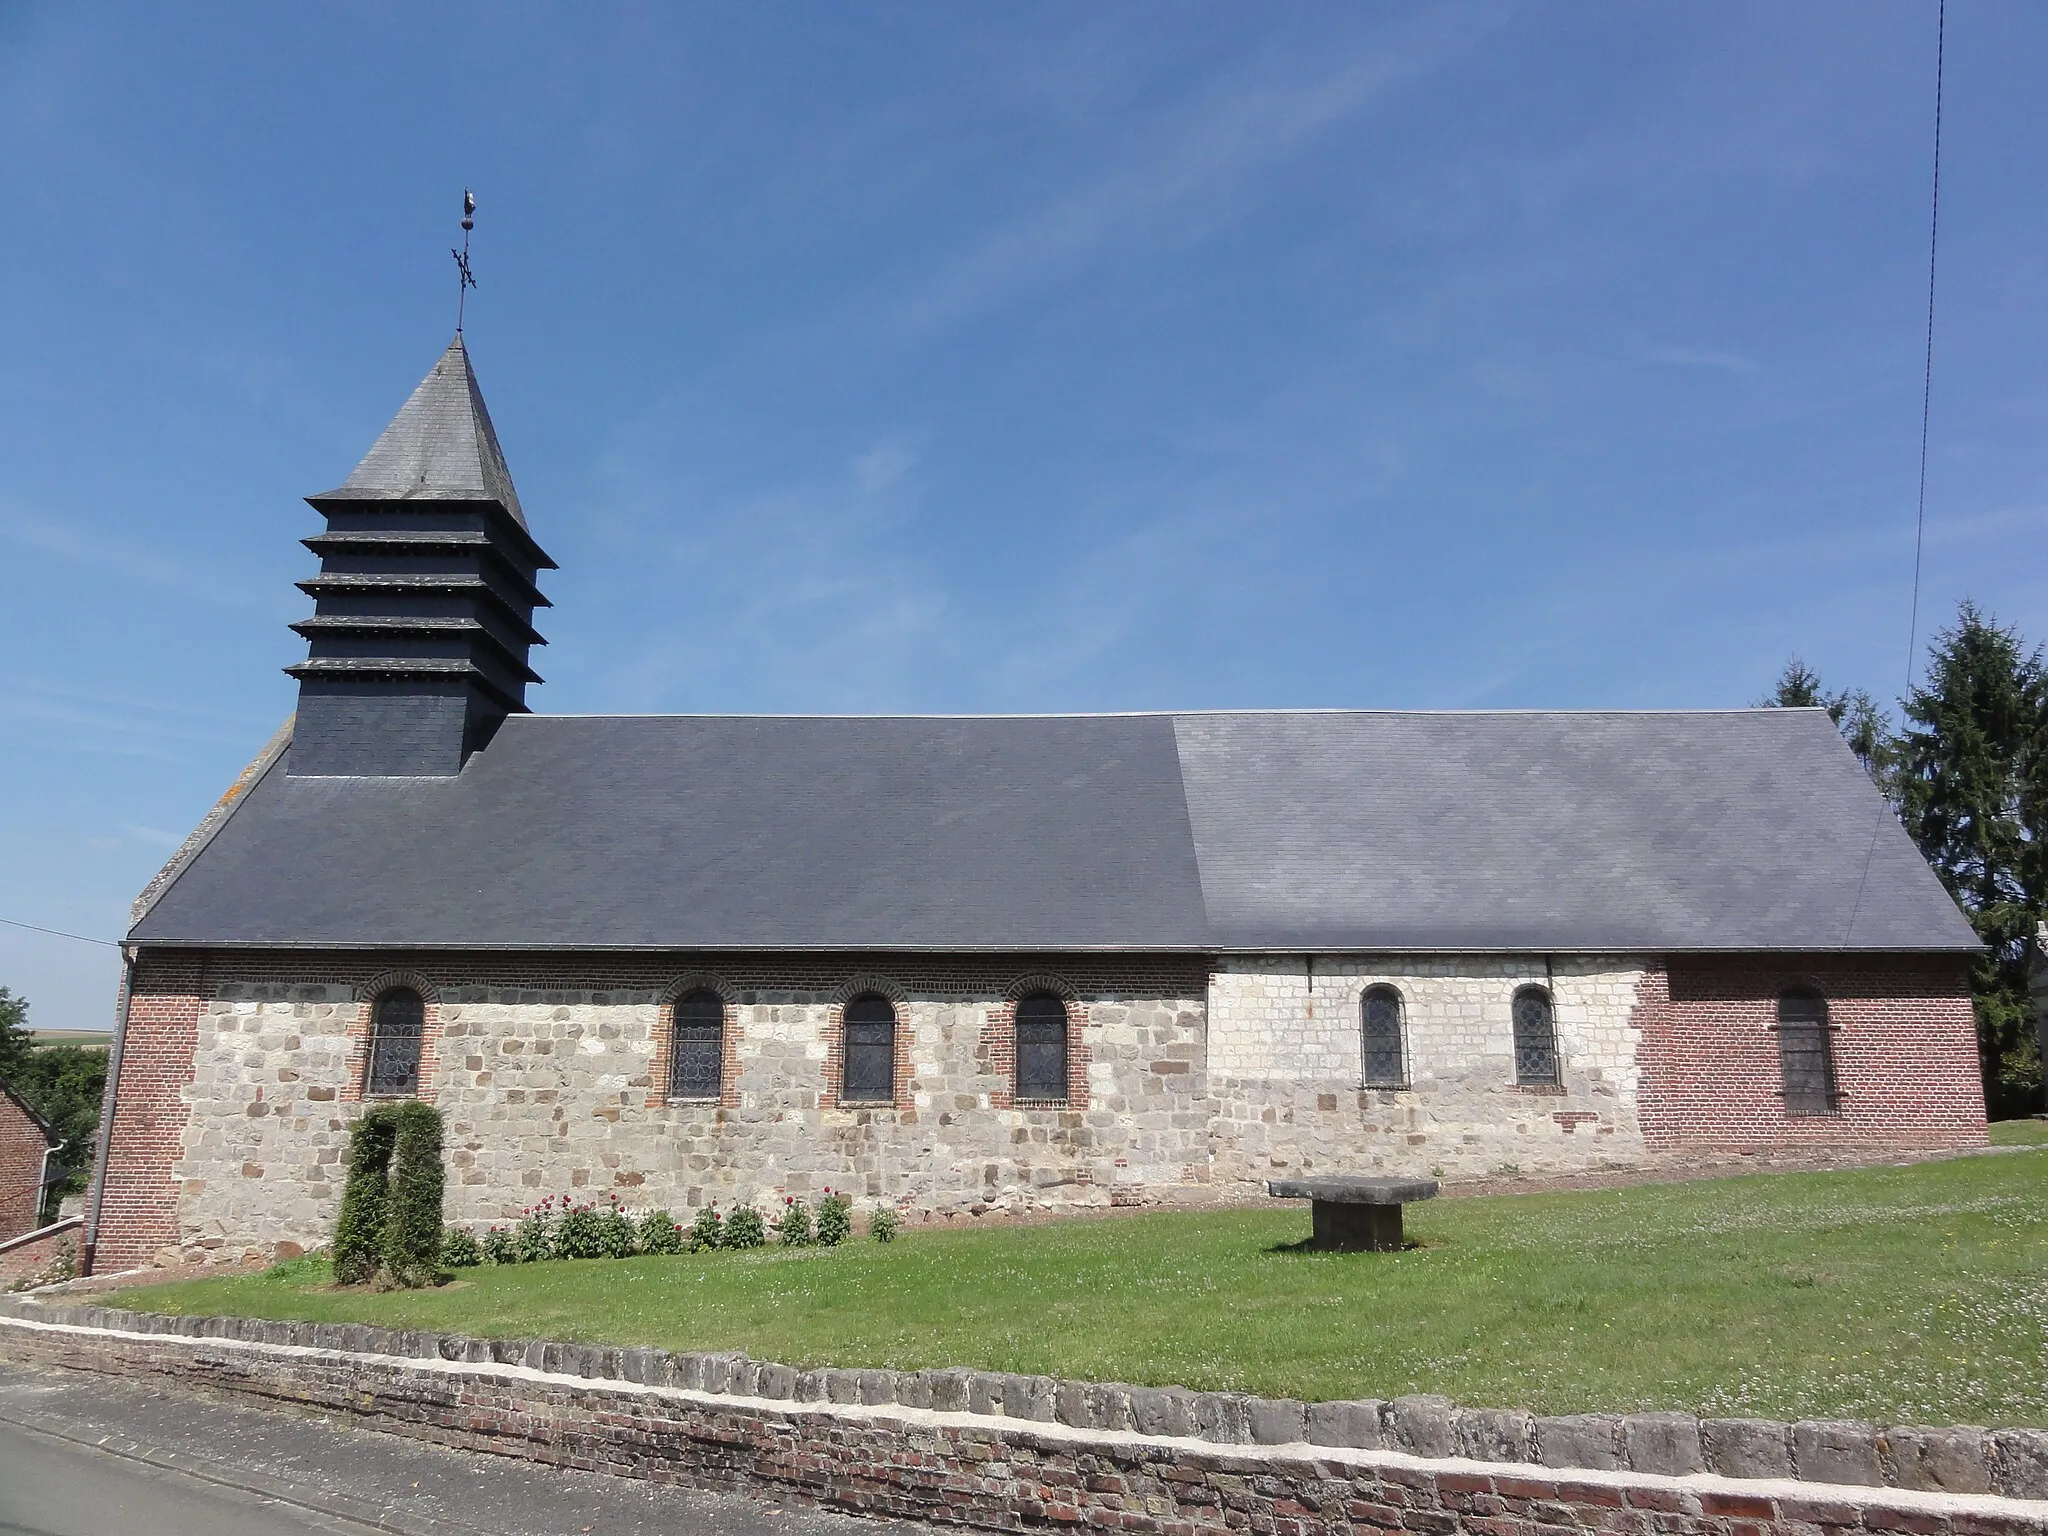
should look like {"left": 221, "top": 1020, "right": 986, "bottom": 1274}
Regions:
{"left": 1892, "top": 602, "right": 2048, "bottom": 1118}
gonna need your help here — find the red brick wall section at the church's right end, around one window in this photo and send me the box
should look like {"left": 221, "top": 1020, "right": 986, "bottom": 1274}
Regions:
{"left": 1634, "top": 954, "right": 1985, "bottom": 1151}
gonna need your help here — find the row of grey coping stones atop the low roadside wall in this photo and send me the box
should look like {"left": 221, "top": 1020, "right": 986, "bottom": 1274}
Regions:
{"left": 0, "top": 1296, "right": 2048, "bottom": 1520}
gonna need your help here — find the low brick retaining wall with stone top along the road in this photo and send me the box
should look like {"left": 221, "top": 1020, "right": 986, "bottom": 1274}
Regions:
{"left": 0, "top": 1307, "right": 2048, "bottom": 1536}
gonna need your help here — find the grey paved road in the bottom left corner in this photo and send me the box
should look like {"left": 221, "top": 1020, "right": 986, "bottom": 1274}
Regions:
{"left": 0, "top": 1362, "right": 922, "bottom": 1536}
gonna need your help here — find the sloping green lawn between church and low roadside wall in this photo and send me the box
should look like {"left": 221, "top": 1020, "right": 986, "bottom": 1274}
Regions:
{"left": 121, "top": 1149, "right": 2048, "bottom": 1425}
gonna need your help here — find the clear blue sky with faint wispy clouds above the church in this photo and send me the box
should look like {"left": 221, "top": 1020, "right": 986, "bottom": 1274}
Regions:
{"left": 0, "top": 0, "right": 2048, "bottom": 1028}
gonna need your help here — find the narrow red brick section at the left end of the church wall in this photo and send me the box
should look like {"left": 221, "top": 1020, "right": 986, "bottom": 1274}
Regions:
{"left": 92, "top": 952, "right": 205, "bottom": 1274}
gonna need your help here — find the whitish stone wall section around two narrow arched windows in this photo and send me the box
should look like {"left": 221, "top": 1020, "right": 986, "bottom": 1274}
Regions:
{"left": 1208, "top": 954, "right": 1649, "bottom": 1192}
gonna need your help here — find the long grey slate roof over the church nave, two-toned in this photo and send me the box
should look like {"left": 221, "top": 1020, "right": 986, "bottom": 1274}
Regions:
{"left": 131, "top": 709, "right": 1976, "bottom": 952}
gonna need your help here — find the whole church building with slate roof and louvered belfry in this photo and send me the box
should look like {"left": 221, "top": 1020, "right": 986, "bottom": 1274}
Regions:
{"left": 88, "top": 336, "right": 1985, "bottom": 1272}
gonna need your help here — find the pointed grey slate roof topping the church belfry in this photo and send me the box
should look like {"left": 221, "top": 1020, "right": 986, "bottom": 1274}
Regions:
{"left": 307, "top": 332, "right": 526, "bottom": 528}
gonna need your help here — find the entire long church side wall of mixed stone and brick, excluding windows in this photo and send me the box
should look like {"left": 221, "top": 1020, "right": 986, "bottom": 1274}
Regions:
{"left": 94, "top": 952, "right": 1985, "bottom": 1272}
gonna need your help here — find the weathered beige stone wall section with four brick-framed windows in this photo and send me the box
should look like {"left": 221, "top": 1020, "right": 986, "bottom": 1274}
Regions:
{"left": 166, "top": 956, "right": 1208, "bottom": 1257}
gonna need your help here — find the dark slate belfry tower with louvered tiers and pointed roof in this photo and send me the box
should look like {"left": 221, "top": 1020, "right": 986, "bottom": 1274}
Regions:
{"left": 285, "top": 336, "right": 555, "bottom": 776}
